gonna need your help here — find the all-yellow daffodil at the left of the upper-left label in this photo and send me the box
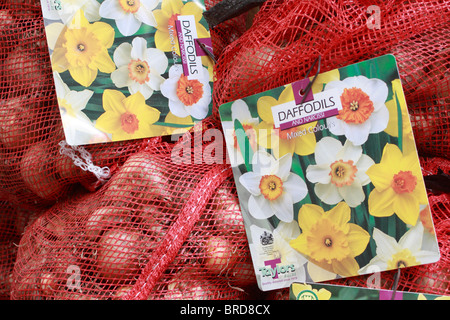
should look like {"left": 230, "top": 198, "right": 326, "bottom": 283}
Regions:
{"left": 51, "top": 10, "right": 116, "bottom": 87}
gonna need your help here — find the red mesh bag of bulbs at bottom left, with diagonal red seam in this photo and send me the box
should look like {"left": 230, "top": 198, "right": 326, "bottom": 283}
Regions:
{"left": 11, "top": 119, "right": 256, "bottom": 300}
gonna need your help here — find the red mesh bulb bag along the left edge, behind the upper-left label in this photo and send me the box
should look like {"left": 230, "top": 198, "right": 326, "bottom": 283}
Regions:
{"left": 0, "top": 0, "right": 159, "bottom": 209}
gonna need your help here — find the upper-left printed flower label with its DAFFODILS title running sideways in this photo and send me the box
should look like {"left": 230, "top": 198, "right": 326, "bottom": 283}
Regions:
{"left": 41, "top": 0, "right": 214, "bottom": 145}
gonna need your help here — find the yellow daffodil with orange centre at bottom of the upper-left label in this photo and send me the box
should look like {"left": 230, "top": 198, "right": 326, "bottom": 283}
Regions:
{"left": 96, "top": 89, "right": 160, "bottom": 141}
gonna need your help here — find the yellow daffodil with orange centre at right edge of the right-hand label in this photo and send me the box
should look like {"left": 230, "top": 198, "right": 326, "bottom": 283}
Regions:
{"left": 366, "top": 144, "right": 428, "bottom": 225}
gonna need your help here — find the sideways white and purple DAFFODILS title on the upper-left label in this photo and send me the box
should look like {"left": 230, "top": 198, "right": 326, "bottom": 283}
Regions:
{"left": 175, "top": 15, "right": 212, "bottom": 80}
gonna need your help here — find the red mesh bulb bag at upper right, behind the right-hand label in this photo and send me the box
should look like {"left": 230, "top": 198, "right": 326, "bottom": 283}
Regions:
{"left": 214, "top": 0, "right": 450, "bottom": 157}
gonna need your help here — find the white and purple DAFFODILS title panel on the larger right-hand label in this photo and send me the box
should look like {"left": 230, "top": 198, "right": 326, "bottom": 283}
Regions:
{"left": 272, "top": 79, "right": 342, "bottom": 130}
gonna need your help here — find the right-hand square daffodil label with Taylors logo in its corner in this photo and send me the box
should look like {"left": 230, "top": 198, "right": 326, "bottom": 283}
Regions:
{"left": 219, "top": 55, "right": 440, "bottom": 290}
